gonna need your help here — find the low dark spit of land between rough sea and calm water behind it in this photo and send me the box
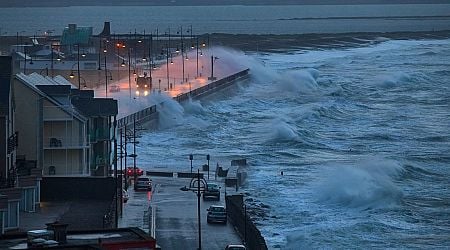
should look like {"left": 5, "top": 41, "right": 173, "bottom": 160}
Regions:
{"left": 0, "top": 30, "right": 450, "bottom": 53}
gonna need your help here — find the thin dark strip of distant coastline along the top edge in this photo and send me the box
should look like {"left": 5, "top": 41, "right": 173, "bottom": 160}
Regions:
{"left": 0, "top": 0, "right": 450, "bottom": 8}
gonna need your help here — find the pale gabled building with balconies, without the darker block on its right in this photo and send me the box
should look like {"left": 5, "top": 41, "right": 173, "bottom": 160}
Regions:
{"left": 13, "top": 73, "right": 90, "bottom": 176}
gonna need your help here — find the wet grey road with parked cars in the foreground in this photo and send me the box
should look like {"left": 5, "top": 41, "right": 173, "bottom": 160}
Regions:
{"left": 119, "top": 177, "right": 242, "bottom": 250}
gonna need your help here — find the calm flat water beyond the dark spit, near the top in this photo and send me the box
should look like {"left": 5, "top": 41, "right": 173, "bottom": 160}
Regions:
{"left": 0, "top": 4, "right": 450, "bottom": 36}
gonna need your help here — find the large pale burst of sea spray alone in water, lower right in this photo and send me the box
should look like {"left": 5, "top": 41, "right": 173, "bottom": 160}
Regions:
{"left": 317, "top": 157, "right": 403, "bottom": 209}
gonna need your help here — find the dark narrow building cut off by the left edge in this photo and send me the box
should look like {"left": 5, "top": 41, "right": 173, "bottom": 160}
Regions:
{"left": 0, "top": 57, "right": 42, "bottom": 234}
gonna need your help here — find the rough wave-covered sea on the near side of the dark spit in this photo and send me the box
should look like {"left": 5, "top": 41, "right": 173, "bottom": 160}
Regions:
{"left": 137, "top": 39, "right": 450, "bottom": 249}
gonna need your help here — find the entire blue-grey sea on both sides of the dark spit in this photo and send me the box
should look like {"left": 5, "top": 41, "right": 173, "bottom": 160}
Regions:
{"left": 0, "top": 4, "right": 450, "bottom": 249}
